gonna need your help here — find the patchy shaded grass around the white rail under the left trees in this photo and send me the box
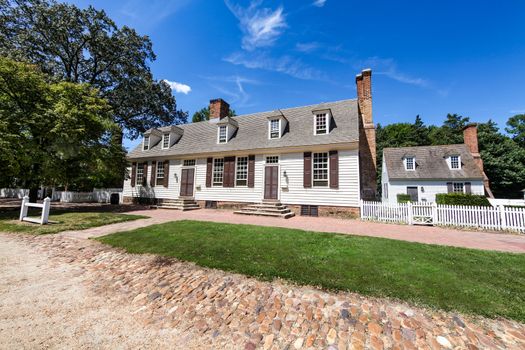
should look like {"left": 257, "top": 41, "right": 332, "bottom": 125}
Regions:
{"left": 0, "top": 211, "right": 145, "bottom": 235}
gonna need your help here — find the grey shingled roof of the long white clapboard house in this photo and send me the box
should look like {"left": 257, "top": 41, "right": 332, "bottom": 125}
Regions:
{"left": 128, "top": 99, "right": 359, "bottom": 159}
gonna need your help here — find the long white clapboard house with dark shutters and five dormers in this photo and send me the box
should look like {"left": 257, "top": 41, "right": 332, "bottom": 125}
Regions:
{"left": 124, "top": 70, "right": 376, "bottom": 217}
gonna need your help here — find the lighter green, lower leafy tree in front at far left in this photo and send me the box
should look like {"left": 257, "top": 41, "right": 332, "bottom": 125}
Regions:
{"left": 0, "top": 57, "right": 125, "bottom": 200}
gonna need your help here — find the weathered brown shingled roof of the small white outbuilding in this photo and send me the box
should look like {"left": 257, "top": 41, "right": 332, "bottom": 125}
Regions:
{"left": 383, "top": 144, "right": 483, "bottom": 180}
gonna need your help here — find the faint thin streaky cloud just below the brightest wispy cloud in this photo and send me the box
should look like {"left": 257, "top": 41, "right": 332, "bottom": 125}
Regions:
{"left": 224, "top": 52, "right": 324, "bottom": 80}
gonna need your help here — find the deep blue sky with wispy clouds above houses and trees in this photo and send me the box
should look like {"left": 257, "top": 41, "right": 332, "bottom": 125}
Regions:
{"left": 68, "top": 0, "right": 525, "bottom": 147}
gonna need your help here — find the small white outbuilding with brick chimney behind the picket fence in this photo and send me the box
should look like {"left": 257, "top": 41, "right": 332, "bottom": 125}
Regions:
{"left": 381, "top": 124, "right": 493, "bottom": 203}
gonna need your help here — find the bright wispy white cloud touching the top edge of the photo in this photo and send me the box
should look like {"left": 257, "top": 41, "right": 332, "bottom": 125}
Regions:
{"left": 225, "top": 0, "right": 287, "bottom": 51}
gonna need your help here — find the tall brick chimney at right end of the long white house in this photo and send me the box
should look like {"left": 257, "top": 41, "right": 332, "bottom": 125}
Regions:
{"left": 355, "top": 69, "right": 377, "bottom": 200}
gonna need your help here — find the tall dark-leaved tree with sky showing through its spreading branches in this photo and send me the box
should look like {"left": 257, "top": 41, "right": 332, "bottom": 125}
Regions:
{"left": 0, "top": 0, "right": 187, "bottom": 142}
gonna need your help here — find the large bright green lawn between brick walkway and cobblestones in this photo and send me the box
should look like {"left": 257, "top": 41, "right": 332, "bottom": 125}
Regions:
{"left": 99, "top": 221, "right": 525, "bottom": 322}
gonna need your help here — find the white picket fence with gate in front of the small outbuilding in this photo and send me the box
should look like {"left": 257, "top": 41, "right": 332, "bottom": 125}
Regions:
{"left": 361, "top": 201, "right": 525, "bottom": 233}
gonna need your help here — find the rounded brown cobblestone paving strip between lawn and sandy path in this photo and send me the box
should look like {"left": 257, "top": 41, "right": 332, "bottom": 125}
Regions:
{"left": 4, "top": 235, "right": 525, "bottom": 350}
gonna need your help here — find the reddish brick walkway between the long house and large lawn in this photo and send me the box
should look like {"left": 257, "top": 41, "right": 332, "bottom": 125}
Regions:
{"left": 64, "top": 209, "right": 525, "bottom": 253}
